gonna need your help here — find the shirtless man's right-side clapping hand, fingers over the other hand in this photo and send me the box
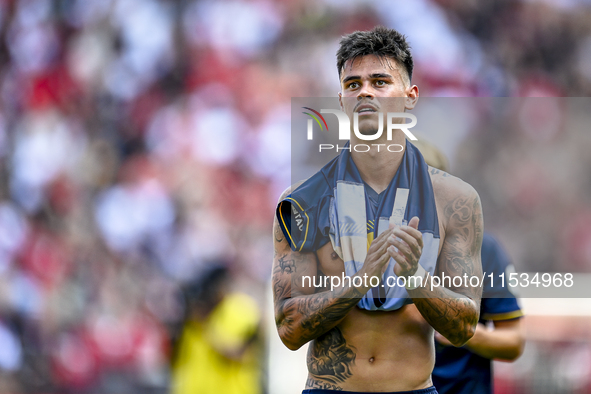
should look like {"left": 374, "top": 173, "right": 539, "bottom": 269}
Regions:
{"left": 388, "top": 216, "right": 423, "bottom": 279}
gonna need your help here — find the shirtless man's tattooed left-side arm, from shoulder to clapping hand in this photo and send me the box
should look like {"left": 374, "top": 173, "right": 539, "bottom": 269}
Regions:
{"left": 272, "top": 191, "right": 390, "bottom": 350}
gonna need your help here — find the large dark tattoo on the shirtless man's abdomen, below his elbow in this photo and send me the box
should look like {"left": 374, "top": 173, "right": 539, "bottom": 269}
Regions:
{"left": 308, "top": 328, "right": 355, "bottom": 385}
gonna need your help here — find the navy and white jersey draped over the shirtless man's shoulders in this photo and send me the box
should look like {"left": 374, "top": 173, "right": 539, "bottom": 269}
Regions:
{"left": 276, "top": 142, "right": 440, "bottom": 310}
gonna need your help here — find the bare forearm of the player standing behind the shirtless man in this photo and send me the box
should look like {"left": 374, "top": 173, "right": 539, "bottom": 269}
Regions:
{"left": 435, "top": 319, "right": 525, "bottom": 361}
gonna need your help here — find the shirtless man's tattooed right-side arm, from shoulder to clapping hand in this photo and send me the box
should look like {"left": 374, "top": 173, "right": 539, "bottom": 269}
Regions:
{"left": 389, "top": 178, "right": 483, "bottom": 346}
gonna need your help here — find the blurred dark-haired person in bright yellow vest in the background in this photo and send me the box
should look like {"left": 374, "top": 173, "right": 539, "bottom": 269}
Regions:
{"left": 171, "top": 267, "right": 262, "bottom": 394}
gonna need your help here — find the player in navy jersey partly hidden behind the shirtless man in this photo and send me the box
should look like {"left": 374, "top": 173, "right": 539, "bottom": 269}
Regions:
{"left": 415, "top": 139, "right": 525, "bottom": 394}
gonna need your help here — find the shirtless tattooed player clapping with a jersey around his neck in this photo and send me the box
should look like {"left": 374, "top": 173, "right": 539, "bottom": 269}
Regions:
{"left": 272, "top": 27, "right": 483, "bottom": 394}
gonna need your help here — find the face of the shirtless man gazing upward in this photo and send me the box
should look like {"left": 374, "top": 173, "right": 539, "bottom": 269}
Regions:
{"left": 339, "top": 55, "right": 419, "bottom": 135}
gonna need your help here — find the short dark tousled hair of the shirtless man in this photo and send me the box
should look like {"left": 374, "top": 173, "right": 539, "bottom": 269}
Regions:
{"left": 337, "top": 26, "right": 413, "bottom": 81}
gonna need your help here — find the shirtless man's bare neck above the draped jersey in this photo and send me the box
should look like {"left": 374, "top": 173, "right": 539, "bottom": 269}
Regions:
{"left": 351, "top": 132, "right": 406, "bottom": 193}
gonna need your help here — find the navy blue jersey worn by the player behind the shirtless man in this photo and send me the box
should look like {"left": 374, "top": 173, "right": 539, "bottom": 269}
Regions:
{"left": 433, "top": 233, "right": 523, "bottom": 394}
